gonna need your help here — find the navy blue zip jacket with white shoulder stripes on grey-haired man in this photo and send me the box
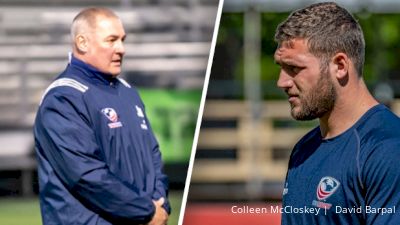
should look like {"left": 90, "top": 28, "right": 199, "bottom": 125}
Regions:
{"left": 34, "top": 57, "right": 170, "bottom": 225}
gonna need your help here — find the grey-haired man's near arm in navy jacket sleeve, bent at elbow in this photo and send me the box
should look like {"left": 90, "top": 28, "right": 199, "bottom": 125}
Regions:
{"left": 35, "top": 90, "right": 156, "bottom": 224}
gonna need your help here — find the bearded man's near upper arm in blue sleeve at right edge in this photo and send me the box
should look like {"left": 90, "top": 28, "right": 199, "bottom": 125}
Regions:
{"left": 362, "top": 140, "right": 400, "bottom": 225}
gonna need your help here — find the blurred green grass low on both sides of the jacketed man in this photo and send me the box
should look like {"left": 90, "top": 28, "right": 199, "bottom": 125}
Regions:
{"left": 0, "top": 191, "right": 183, "bottom": 225}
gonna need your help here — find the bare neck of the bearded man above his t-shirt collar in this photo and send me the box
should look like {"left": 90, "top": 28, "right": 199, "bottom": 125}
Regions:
{"left": 319, "top": 79, "right": 378, "bottom": 139}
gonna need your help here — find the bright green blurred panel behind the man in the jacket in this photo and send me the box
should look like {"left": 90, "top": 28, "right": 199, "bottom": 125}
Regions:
{"left": 139, "top": 88, "right": 201, "bottom": 163}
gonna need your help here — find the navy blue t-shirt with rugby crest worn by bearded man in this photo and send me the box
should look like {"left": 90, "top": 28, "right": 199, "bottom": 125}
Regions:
{"left": 282, "top": 105, "right": 400, "bottom": 225}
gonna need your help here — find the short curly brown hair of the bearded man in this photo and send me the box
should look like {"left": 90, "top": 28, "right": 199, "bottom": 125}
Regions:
{"left": 275, "top": 2, "right": 365, "bottom": 76}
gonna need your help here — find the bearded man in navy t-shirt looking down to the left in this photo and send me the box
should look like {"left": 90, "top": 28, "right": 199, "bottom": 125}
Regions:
{"left": 274, "top": 2, "right": 400, "bottom": 225}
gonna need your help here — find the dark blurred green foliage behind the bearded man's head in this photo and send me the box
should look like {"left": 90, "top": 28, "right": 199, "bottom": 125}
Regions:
{"left": 208, "top": 11, "right": 400, "bottom": 99}
